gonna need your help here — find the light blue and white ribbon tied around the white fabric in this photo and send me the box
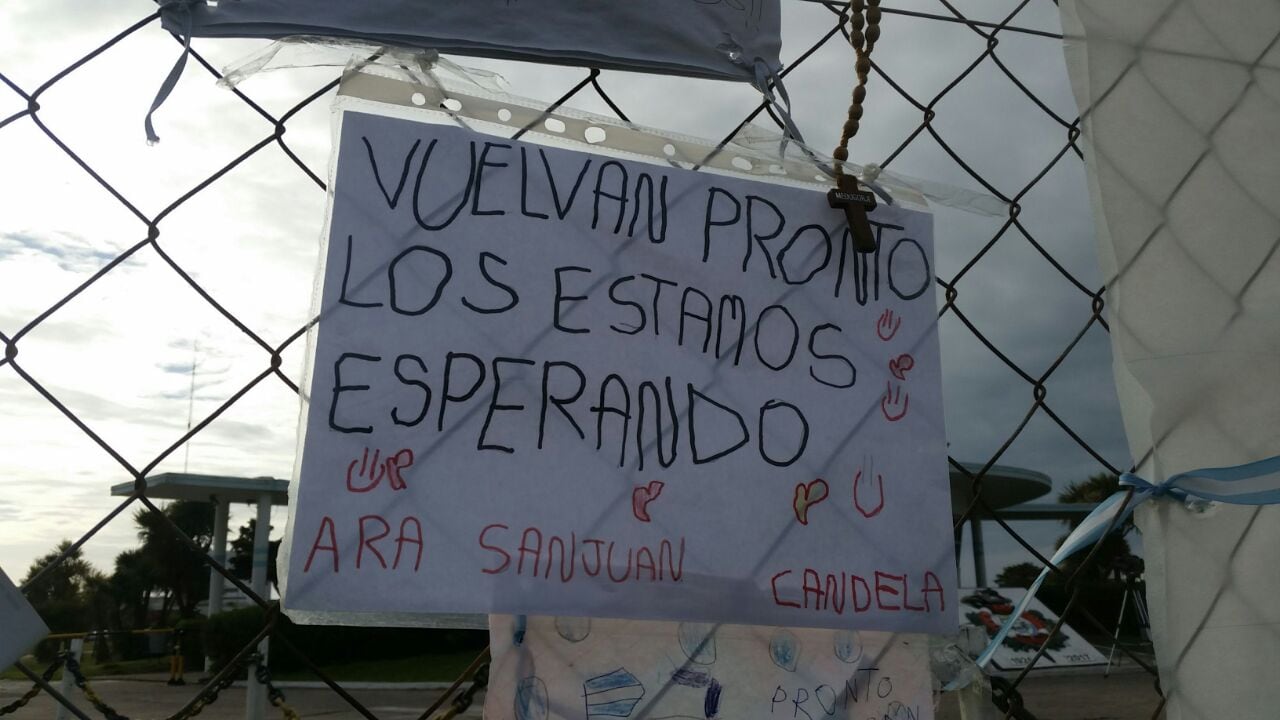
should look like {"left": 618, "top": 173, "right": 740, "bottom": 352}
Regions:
{"left": 967, "top": 455, "right": 1280, "bottom": 671}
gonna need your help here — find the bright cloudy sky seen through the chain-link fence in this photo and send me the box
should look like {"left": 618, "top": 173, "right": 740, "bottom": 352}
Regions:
{"left": 0, "top": 0, "right": 1130, "bottom": 589}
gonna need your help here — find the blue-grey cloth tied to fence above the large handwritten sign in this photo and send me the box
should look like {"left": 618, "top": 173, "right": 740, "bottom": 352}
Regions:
{"left": 161, "top": 0, "right": 782, "bottom": 81}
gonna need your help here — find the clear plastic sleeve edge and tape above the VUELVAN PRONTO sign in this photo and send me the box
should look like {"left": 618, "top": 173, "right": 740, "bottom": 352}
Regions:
{"left": 221, "top": 36, "right": 1009, "bottom": 217}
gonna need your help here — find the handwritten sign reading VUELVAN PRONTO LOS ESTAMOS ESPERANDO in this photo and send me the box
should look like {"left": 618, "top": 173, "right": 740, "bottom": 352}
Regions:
{"left": 285, "top": 106, "right": 955, "bottom": 632}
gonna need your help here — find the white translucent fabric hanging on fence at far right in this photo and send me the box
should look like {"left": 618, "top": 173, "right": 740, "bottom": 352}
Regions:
{"left": 1061, "top": 0, "right": 1280, "bottom": 720}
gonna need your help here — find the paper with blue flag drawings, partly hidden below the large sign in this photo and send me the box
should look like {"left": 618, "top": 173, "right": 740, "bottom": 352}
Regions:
{"left": 484, "top": 615, "right": 933, "bottom": 720}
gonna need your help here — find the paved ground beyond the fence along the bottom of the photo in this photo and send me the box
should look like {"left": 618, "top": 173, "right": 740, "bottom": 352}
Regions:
{"left": 0, "top": 671, "right": 1160, "bottom": 720}
